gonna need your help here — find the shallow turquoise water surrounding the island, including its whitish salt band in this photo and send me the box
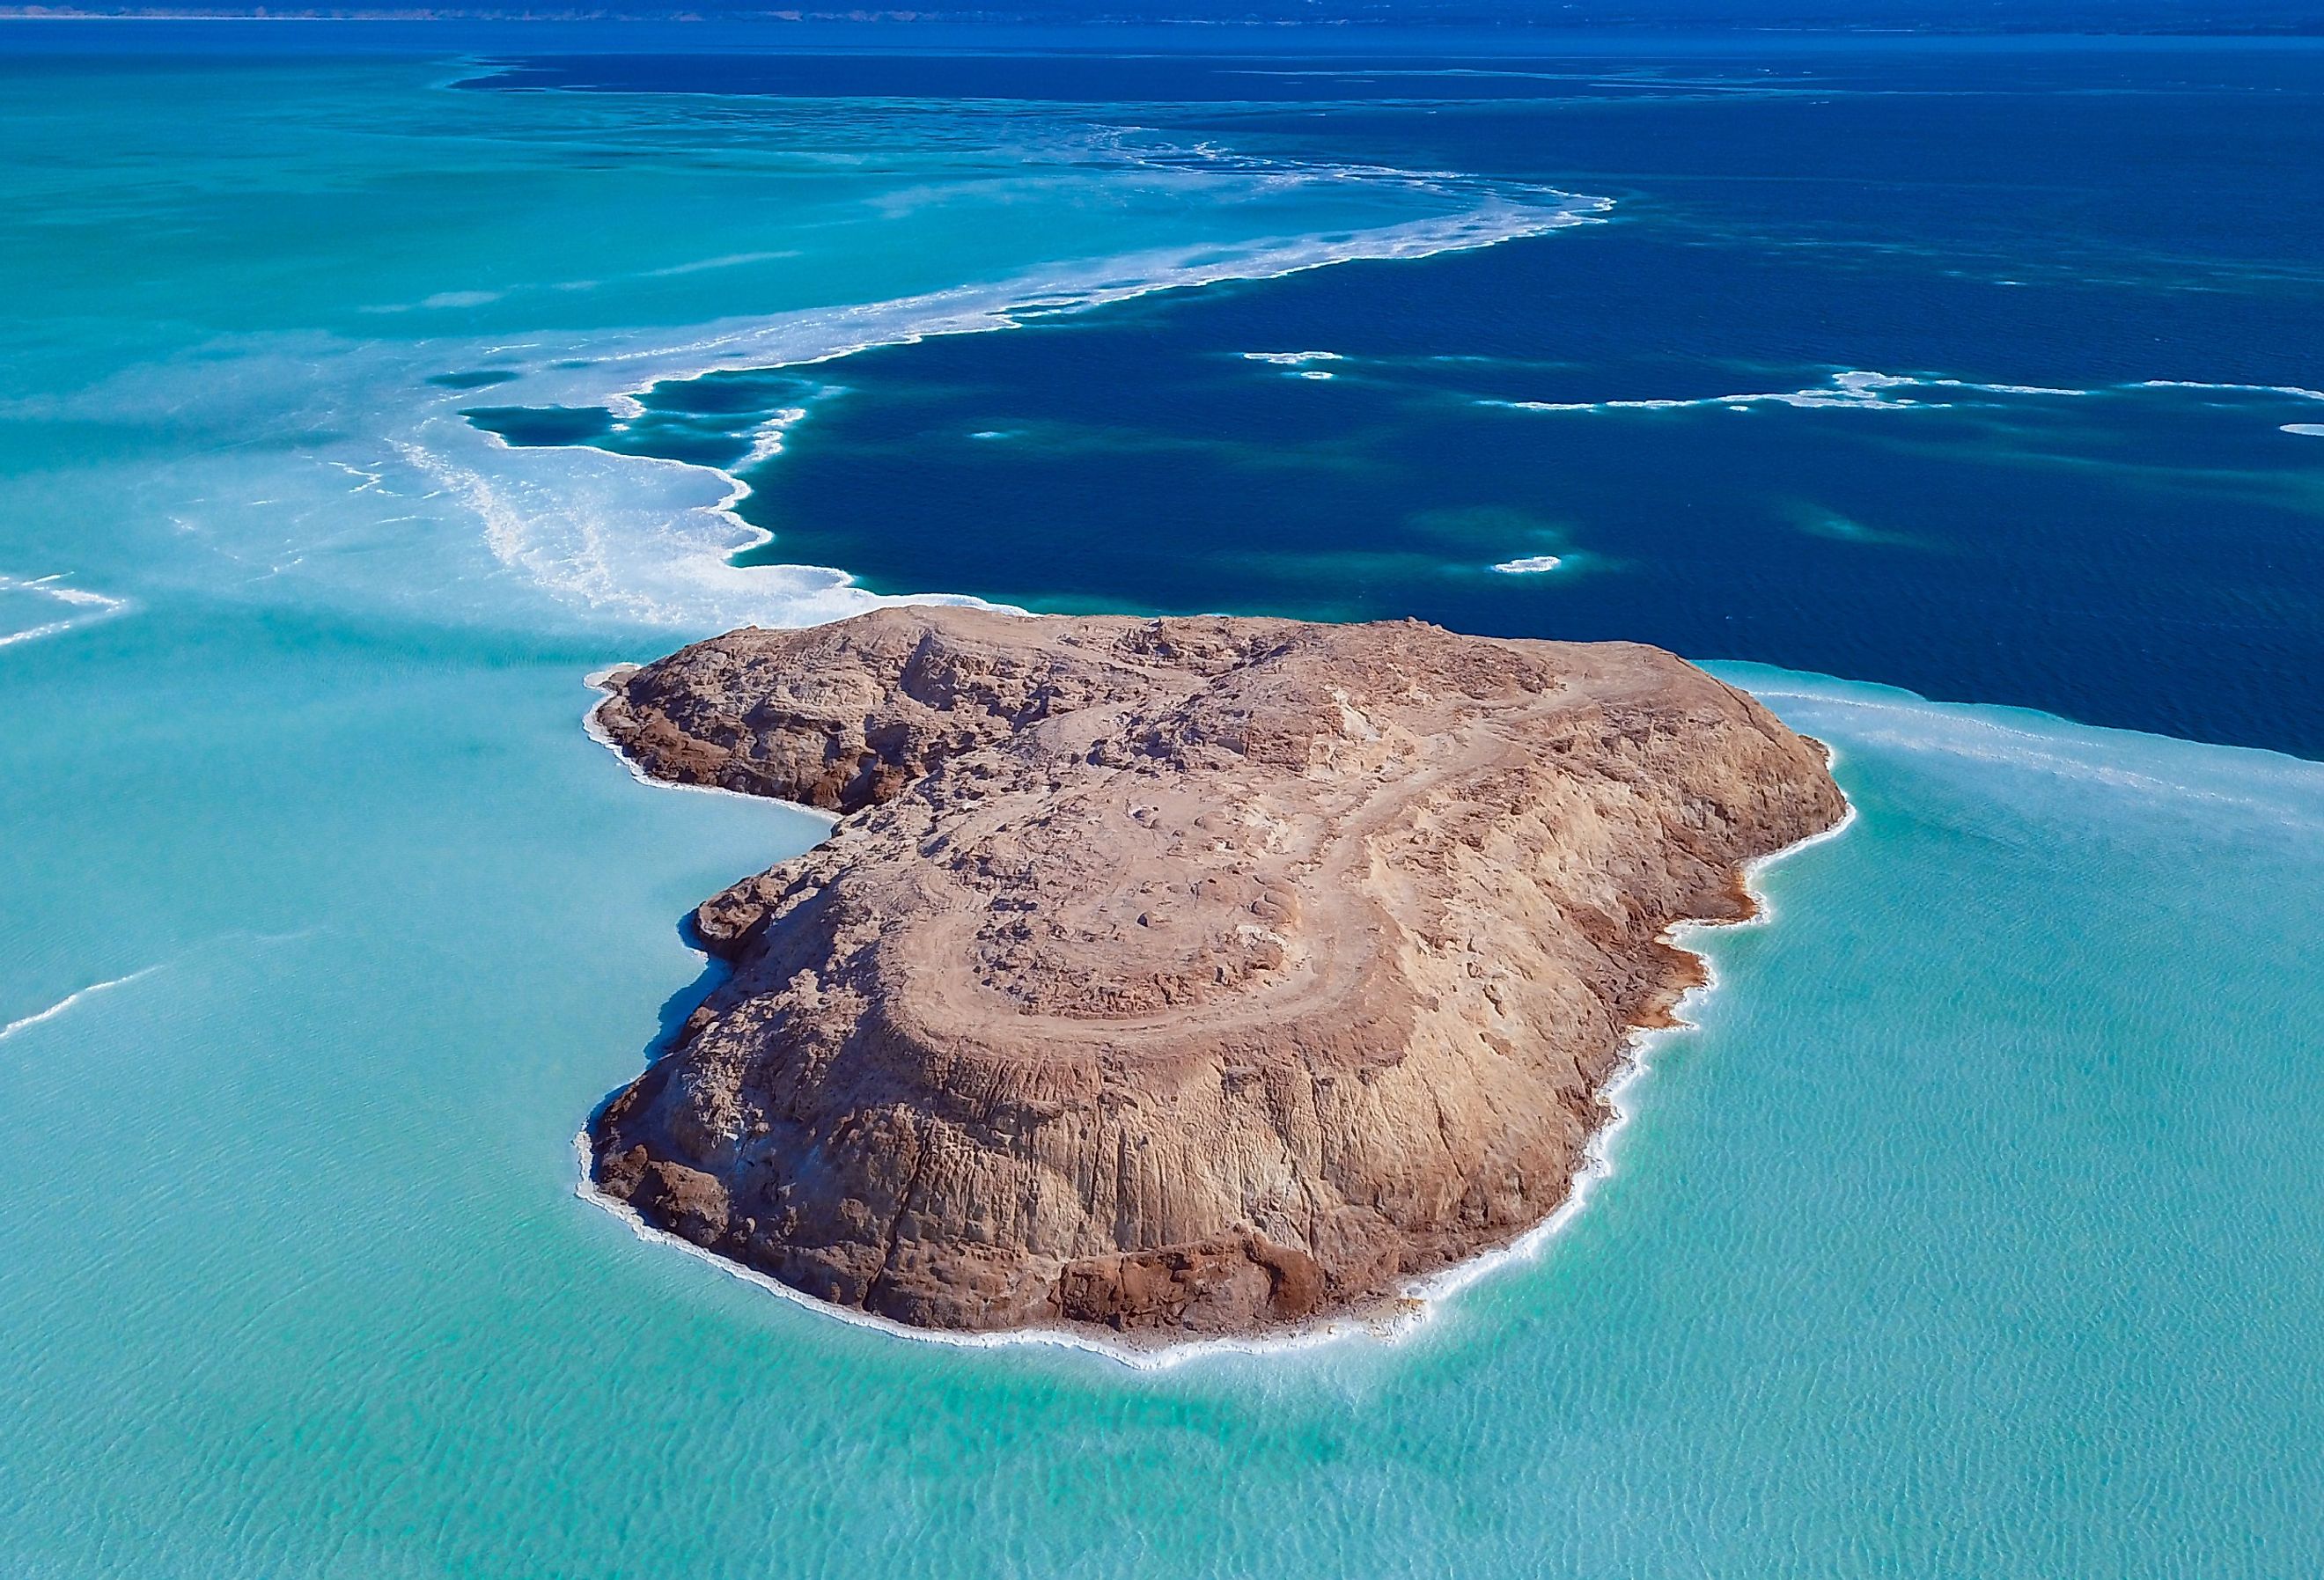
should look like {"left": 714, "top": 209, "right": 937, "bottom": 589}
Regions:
{"left": 0, "top": 27, "right": 2324, "bottom": 1577}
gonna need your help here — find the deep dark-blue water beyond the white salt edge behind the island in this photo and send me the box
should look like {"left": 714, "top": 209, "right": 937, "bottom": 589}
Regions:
{"left": 479, "top": 40, "right": 2324, "bottom": 755}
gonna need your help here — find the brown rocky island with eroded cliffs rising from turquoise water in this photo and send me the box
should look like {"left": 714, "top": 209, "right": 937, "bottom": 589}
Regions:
{"left": 591, "top": 609, "right": 1845, "bottom": 1341}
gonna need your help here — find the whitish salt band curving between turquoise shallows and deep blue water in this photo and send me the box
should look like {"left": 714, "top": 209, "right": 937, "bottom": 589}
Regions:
{"left": 0, "top": 151, "right": 1611, "bottom": 635}
